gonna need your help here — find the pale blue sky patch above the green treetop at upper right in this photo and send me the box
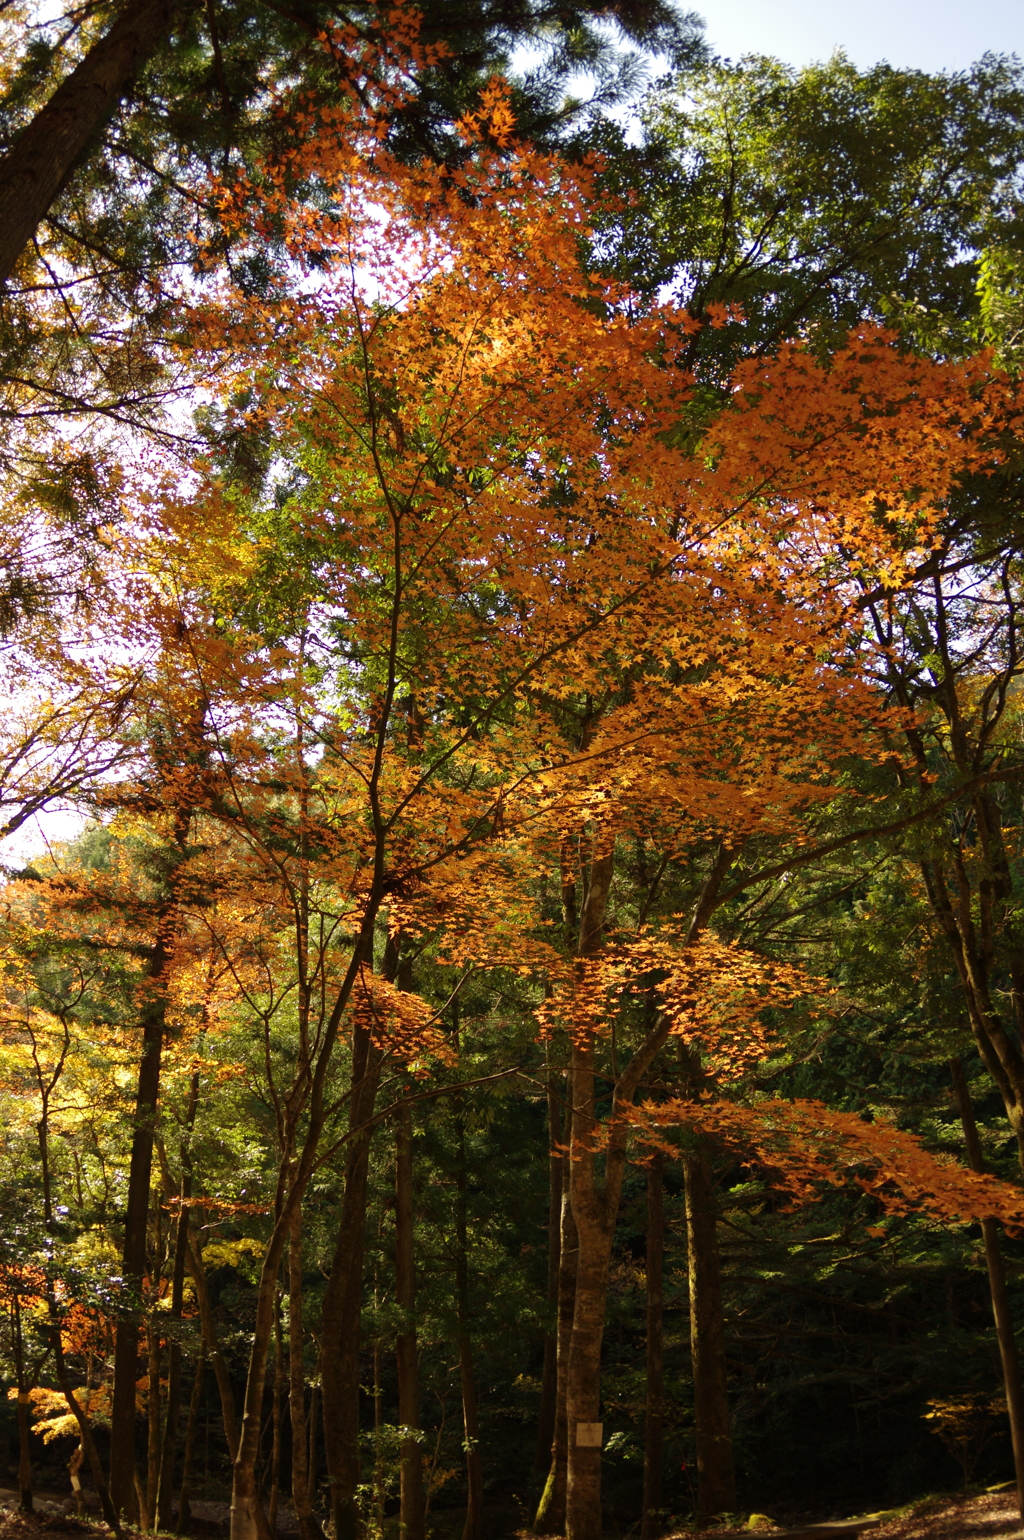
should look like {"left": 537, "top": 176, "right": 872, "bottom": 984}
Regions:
{"left": 699, "top": 0, "right": 1024, "bottom": 71}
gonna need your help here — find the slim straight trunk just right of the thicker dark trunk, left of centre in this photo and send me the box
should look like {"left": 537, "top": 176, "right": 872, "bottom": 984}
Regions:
{"left": 394, "top": 1096, "right": 423, "bottom": 1540}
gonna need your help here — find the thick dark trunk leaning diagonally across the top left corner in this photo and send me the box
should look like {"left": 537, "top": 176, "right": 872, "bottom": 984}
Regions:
{"left": 0, "top": 0, "right": 174, "bottom": 283}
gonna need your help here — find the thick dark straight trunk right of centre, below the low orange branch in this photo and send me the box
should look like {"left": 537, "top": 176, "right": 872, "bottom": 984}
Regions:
{"left": 682, "top": 1146, "right": 736, "bottom": 1525}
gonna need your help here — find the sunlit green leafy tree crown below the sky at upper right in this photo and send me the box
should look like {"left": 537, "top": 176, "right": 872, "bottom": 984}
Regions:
{"left": 582, "top": 54, "right": 1024, "bottom": 374}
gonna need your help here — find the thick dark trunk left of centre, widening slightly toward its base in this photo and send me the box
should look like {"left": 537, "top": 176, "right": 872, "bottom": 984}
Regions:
{"left": 320, "top": 1026, "right": 380, "bottom": 1540}
